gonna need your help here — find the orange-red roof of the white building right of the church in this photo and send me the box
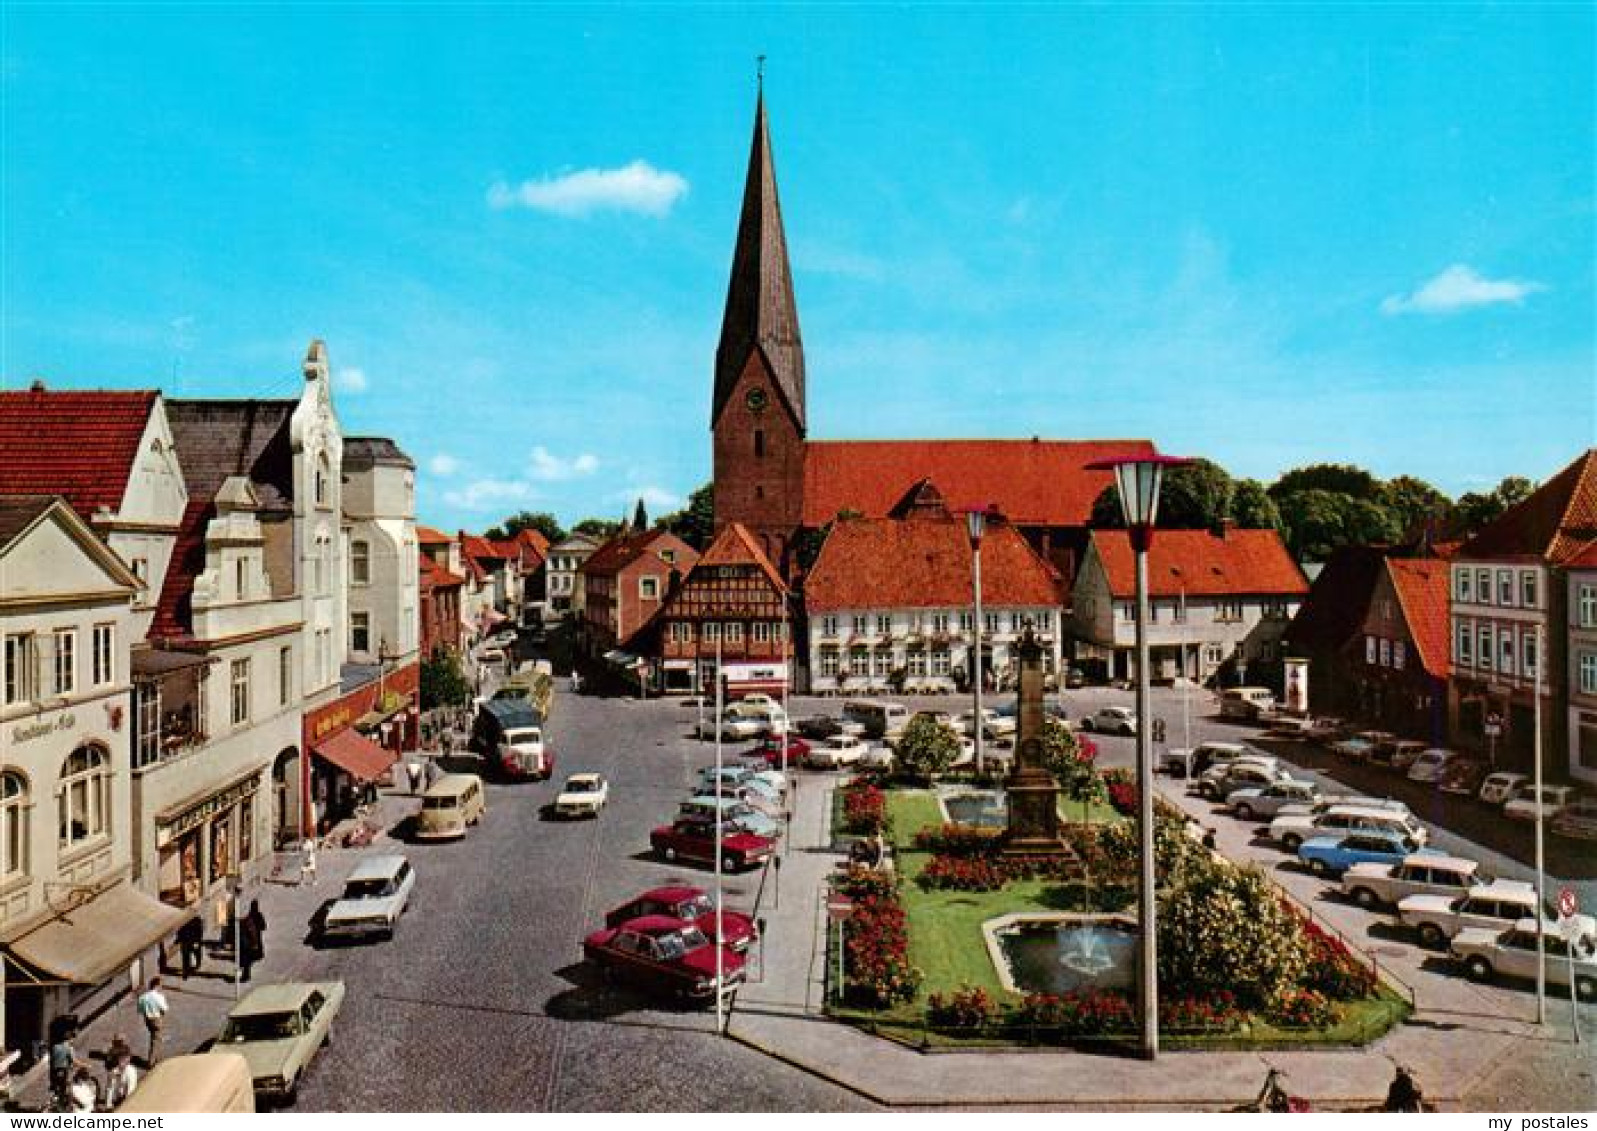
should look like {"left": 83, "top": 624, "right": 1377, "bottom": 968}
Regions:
{"left": 1085, "top": 529, "right": 1308, "bottom": 597}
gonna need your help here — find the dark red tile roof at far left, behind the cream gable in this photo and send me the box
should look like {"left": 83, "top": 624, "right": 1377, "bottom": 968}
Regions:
{"left": 0, "top": 388, "right": 160, "bottom": 519}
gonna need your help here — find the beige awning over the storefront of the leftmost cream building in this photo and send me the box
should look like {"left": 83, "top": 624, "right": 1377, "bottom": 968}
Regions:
{"left": 5, "top": 883, "right": 195, "bottom": 986}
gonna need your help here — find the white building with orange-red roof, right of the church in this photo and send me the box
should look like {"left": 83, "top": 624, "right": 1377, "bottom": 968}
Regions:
{"left": 1073, "top": 524, "right": 1308, "bottom": 690}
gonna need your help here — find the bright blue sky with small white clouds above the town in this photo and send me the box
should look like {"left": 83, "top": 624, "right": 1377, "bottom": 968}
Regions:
{"left": 0, "top": 5, "right": 1597, "bottom": 529}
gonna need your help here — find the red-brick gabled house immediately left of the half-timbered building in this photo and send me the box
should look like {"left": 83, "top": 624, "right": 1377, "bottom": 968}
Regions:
{"left": 580, "top": 529, "right": 698, "bottom": 660}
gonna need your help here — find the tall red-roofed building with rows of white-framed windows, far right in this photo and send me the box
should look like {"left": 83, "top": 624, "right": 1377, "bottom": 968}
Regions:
{"left": 1448, "top": 449, "right": 1597, "bottom": 780}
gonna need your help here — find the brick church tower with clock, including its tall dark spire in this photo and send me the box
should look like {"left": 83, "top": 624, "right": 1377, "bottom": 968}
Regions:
{"left": 709, "top": 91, "right": 805, "bottom": 573}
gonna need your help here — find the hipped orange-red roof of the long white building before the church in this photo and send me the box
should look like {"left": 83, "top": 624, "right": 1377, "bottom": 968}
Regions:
{"left": 805, "top": 518, "right": 1062, "bottom": 613}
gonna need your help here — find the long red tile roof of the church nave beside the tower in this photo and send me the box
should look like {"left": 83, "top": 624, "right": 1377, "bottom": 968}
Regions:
{"left": 803, "top": 439, "right": 1153, "bottom": 527}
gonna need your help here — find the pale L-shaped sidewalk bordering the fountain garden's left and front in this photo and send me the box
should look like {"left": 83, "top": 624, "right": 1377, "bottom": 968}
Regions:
{"left": 728, "top": 778, "right": 1567, "bottom": 1110}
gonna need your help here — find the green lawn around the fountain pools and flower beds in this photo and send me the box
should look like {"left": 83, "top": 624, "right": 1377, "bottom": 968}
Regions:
{"left": 835, "top": 789, "right": 1409, "bottom": 1048}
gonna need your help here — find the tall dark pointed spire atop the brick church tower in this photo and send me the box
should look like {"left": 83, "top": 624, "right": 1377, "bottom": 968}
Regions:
{"left": 711, "top": 85, "right": 805, "bottom": 435}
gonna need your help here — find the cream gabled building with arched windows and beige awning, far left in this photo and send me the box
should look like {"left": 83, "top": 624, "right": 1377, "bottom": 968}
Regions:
{"left": 0, "top": 498, "right": 179, "bottom": 1053}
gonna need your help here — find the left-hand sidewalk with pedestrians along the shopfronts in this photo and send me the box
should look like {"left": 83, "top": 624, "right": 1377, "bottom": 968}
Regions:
{"left": 13, "top": 789, "right": 417, "bottom": 1110}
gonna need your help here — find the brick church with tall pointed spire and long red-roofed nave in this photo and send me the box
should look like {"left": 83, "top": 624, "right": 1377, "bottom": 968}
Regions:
{"left": 711, "top": 91, "right": 1153, "bottom": 593}
